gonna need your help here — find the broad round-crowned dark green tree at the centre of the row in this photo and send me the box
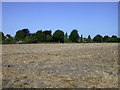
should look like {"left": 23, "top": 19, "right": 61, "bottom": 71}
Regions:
{"left": 53, "top": 30, "right": 64, "bottom": 43}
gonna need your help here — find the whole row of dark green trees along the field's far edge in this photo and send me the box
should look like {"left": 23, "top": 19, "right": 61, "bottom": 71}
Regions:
{"left": 0, "top": 29, "right": 120, "bottom": 44}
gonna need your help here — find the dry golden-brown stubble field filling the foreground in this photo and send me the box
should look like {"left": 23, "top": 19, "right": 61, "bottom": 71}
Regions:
{"left": 2, "top": 43, "right": 118, "bottom": 88}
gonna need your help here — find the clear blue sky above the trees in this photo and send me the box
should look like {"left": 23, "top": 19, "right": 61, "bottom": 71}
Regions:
{"left": 2, "top": 2, "right": 118, "bottom": 37}
